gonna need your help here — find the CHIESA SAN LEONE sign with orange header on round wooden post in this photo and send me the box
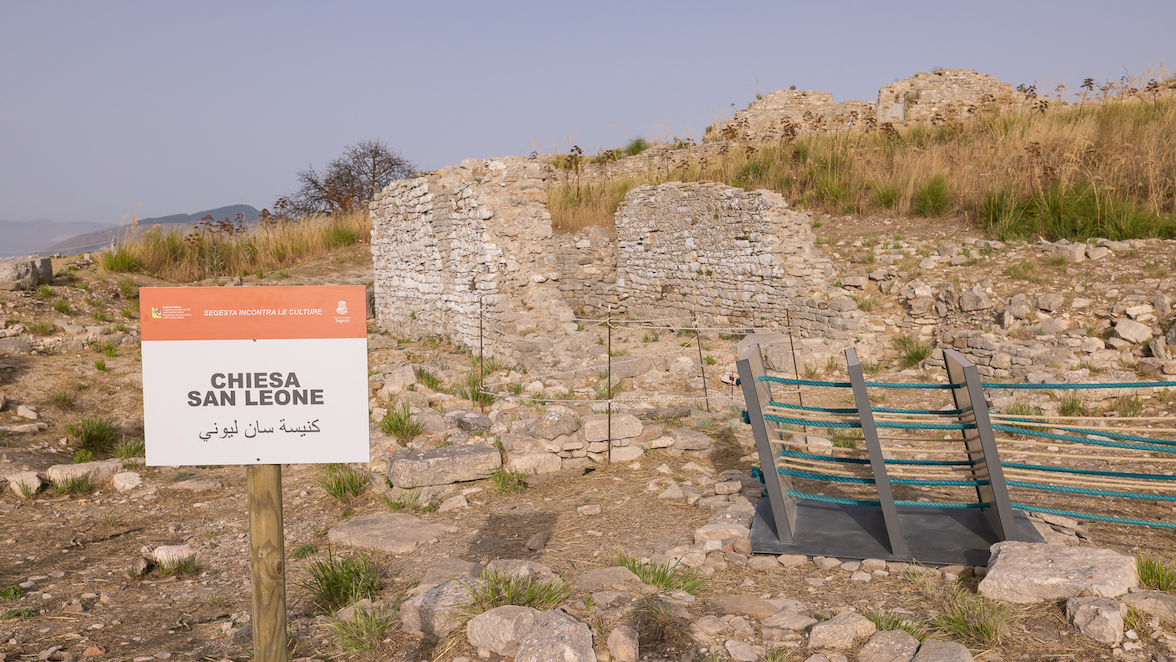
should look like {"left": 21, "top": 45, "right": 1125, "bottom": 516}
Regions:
{"left": 139, "top": 286, "right": 370, "bottom": 662}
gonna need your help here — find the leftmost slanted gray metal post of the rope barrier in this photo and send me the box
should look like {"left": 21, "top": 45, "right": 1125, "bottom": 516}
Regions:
{"left": 736, "top": 345, "right": 796, "bottom": 543}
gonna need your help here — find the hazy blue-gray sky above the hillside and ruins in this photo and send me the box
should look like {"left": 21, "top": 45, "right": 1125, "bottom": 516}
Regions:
{"left": 0, "top": 0, "right": 1176, "bottom": 226}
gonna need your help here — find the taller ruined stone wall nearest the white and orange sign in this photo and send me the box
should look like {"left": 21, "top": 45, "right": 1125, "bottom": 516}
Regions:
{"left": 370, "top": 158, "right": 616, "bottom": 362}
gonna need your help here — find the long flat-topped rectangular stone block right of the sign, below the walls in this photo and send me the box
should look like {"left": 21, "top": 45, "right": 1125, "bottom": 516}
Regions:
{"left": 388, "top": 443, "right": 502, "bottom": 489}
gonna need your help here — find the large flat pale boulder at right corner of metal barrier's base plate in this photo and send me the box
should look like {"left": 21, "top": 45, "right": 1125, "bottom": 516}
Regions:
{"left": 980, "top": 541, "right": 1140, "bottom": 603}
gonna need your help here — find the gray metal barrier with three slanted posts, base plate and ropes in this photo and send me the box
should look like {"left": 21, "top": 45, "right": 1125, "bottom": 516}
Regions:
{"left": 737, "top": 346, "right": 1042, "bottom": 564}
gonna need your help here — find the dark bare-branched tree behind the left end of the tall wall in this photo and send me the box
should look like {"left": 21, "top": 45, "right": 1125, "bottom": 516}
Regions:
{"left": 288, "top": 139, "right": 416, "bottom": 214}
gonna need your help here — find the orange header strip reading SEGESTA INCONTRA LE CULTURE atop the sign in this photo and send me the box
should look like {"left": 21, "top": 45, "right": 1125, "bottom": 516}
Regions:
{"left": 139, "top": 286, "right": 367, "bottom": 341}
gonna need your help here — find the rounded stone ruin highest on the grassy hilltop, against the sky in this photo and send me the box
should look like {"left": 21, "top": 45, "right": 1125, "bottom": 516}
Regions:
{"left": 876, "top": 69, "right": 1025, "bottom": 122}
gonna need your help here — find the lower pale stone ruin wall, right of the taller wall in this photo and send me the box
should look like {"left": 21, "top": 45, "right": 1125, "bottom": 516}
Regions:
{"left": 616, "top": 182, "right": 861, "bottom": 337}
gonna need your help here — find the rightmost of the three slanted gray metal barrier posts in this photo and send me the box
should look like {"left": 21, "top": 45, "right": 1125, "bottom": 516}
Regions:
{"left": 943, "top": 349, "right": 1025, "bottom": 540}
